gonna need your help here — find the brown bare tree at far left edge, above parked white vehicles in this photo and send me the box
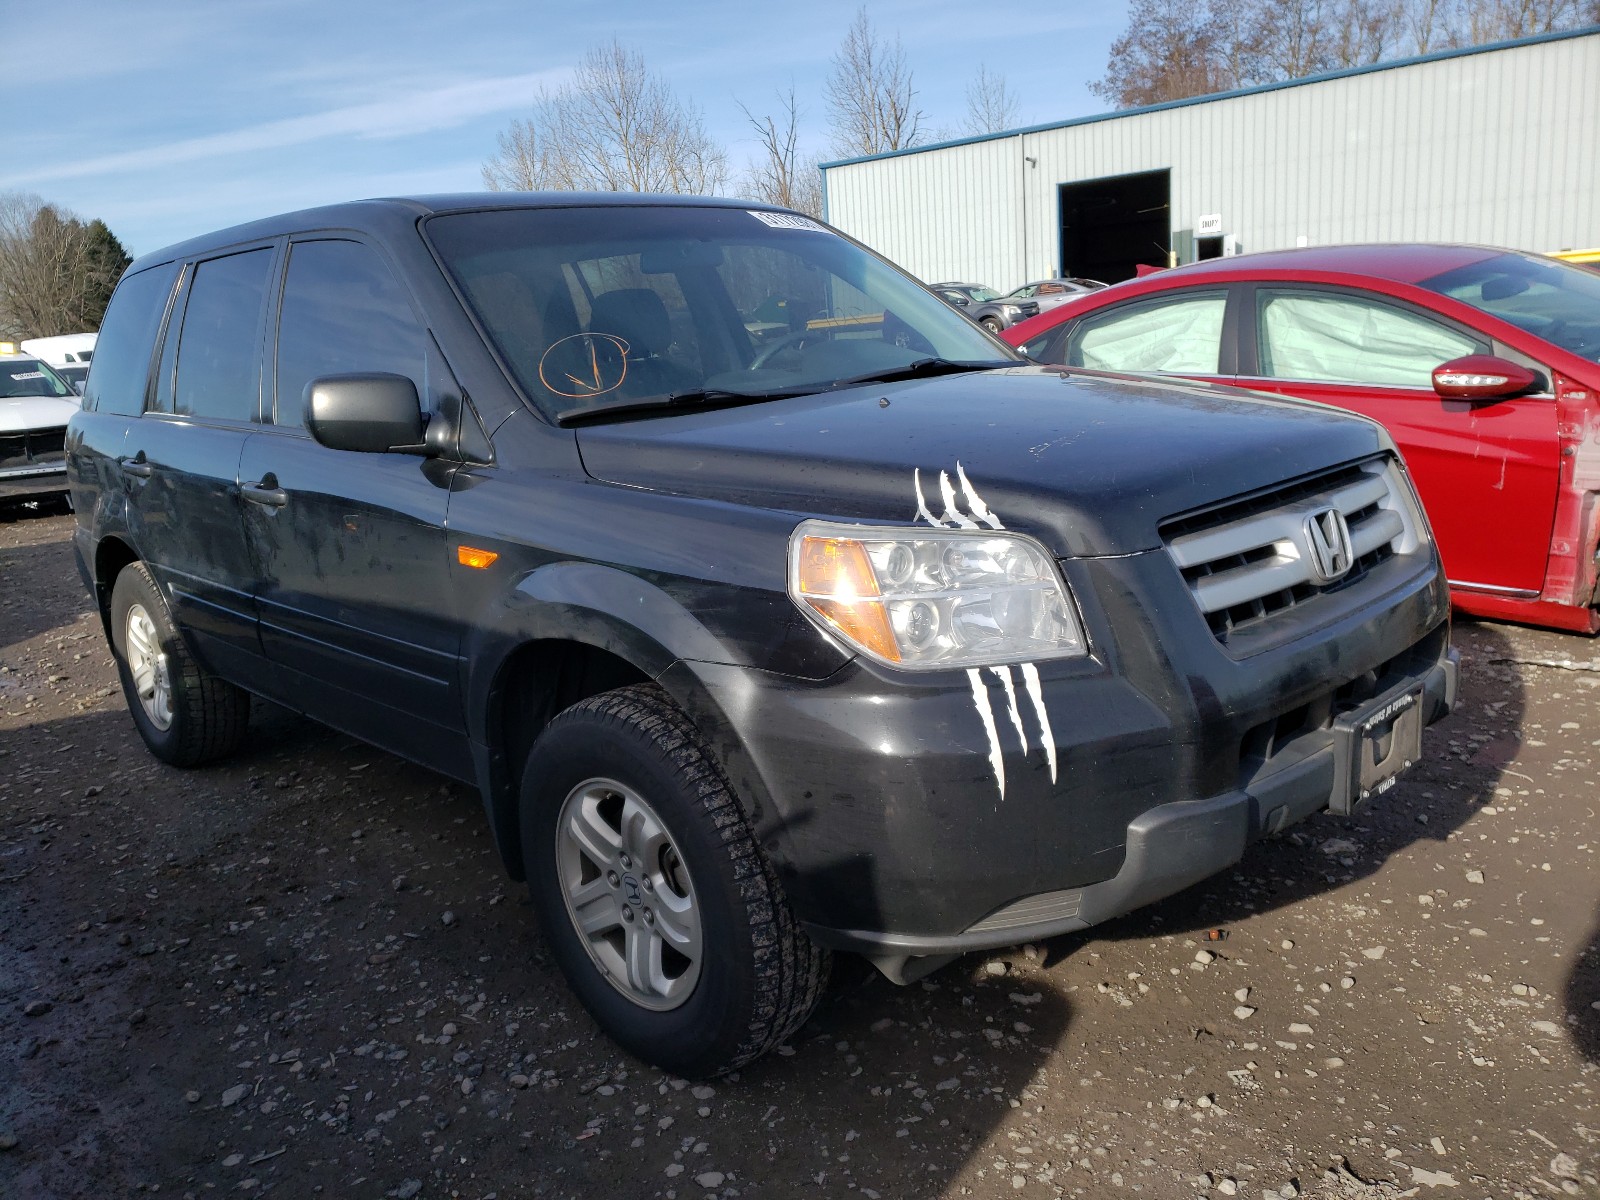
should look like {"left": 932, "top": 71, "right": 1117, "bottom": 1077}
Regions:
{"left": 0, "top": 192, "right": 128, "bottom": 339}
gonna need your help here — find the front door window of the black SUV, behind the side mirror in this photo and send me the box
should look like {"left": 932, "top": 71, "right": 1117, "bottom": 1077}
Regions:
{"left": 274, "top": 240, "right": 427, "bottom": 426}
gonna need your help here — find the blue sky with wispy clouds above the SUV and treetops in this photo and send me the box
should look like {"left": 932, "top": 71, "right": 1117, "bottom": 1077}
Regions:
{"left": 0, "top": 0, "right": 1126, "bottom": 253}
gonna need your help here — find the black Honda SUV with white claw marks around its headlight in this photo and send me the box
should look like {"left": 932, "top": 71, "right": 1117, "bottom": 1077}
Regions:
{"left": 67, "top": 194, "right": 1456, "bottom": 1075}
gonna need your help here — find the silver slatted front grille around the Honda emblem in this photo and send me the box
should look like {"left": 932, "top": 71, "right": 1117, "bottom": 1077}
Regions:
{"left": 1162, "top": 458, "right": 1422, "bottom": 642}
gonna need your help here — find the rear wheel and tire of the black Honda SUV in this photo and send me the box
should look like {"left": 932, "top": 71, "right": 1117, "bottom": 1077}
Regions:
{"left": 110, "top": 562, "right": 250, "bottom": 766}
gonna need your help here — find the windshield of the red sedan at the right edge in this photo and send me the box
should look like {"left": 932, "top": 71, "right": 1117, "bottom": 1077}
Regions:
{"left": 1422, "top": 254, "right": 1600, "bottom": 362}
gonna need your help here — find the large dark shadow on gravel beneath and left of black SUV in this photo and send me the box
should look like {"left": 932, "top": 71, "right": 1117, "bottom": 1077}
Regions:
{"left": 0, "top": 701, "right": 1070, "bottom": 1197}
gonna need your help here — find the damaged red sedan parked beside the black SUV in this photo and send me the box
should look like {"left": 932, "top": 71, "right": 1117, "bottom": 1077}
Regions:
{"left": 1002, "top": 245, "right": 1600, "bottom": 634}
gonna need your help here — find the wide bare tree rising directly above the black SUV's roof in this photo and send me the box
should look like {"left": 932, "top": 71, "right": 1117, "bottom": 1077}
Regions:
{"left": 483, "top": 42, "right": 728, "bottom": 195}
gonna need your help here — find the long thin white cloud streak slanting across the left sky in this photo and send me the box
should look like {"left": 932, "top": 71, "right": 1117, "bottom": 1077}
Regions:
{"left": 8, "top": 69, "right": 570, "bottom": 187}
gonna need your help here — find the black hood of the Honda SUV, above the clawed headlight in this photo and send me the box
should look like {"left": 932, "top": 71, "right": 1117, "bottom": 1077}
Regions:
{"left": 576, "top": 366, "right": 1389, "bottom": 557}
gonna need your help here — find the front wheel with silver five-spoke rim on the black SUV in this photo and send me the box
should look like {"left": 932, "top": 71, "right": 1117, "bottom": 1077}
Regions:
{"left": 522, "top": 685, "right": 829, "bottom": 1078}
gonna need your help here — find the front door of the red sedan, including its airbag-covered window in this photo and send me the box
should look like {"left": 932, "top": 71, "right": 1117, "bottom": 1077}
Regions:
{"left": 1238, "top": 283, "right": 1560, "bottom": 597}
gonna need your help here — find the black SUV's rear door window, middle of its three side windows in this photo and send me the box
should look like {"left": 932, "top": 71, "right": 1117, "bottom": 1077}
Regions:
{"left": 173, "top": 248, "right": 272, "bottom": 421}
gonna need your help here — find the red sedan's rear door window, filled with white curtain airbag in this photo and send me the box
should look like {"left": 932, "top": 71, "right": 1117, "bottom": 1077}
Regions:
{"left": 1067, "top": 291, "right": 1227, "bottom": 374}
